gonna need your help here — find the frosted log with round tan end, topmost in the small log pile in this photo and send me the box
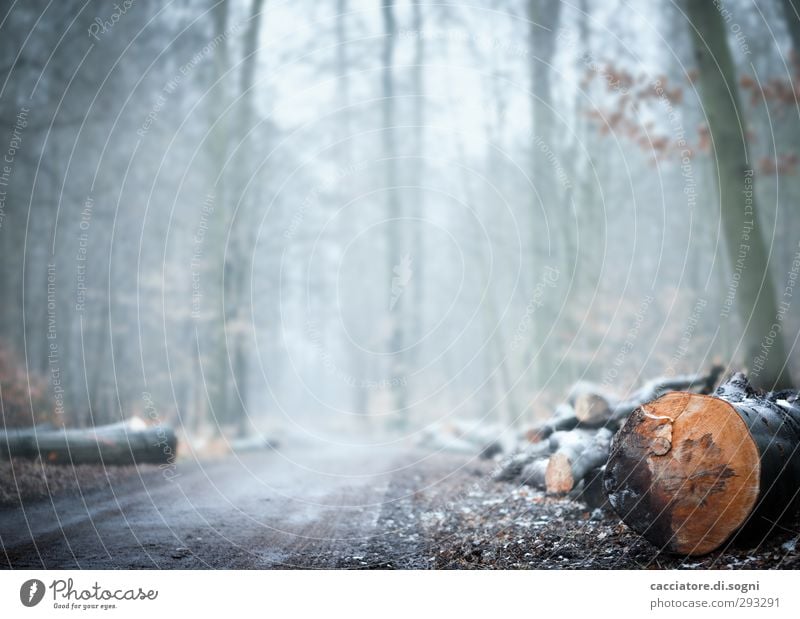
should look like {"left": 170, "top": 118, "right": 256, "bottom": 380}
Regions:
{"left": 575, "top": 365, "right": 723, "bottom": 427}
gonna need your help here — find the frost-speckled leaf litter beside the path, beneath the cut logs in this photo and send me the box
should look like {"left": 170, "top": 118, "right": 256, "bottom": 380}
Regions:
{"left": 422, "top": 460, "right": 800, "bottom": 569}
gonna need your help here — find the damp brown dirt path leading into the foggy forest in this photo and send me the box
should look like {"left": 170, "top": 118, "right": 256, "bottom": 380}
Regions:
{"left": 0, "top": 446, "right": 479, "bottom": 569}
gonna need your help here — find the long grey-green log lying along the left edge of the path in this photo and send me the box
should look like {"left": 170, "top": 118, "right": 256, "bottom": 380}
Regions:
{"left": 0, "top": 422, "right": 177, "bottom": 465}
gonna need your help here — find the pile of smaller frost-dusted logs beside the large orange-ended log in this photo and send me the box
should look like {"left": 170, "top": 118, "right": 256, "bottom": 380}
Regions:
{"left": 494, "top": 366, "right": 722, "bottom": 496}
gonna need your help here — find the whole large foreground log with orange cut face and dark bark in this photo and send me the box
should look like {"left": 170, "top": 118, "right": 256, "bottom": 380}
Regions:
{"left": 604, "top": 374, "right": 800, "bottom": 555}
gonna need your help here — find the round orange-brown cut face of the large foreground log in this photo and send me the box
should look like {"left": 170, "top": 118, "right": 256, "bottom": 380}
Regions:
{"left": 604, "top": 392, "right": 760, "bottom": 555}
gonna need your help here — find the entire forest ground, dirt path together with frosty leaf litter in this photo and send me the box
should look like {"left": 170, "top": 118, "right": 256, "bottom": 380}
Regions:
{"left": 0, "top": 450, "right": 800, "bottom": 569}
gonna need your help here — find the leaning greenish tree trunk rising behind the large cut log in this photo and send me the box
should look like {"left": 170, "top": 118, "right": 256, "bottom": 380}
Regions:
{"left": 686, "top": 2, "right": 790, "bottom": 388}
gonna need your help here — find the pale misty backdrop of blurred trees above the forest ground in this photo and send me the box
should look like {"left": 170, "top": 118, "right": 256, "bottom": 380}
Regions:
{"left": 0, "top": 0, "right": 800, "bottom": 453}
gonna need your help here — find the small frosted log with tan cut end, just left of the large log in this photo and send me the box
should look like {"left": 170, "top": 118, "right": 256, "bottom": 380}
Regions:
{"left": 545, "top": 428, "right": 613, "bottom": 494}
